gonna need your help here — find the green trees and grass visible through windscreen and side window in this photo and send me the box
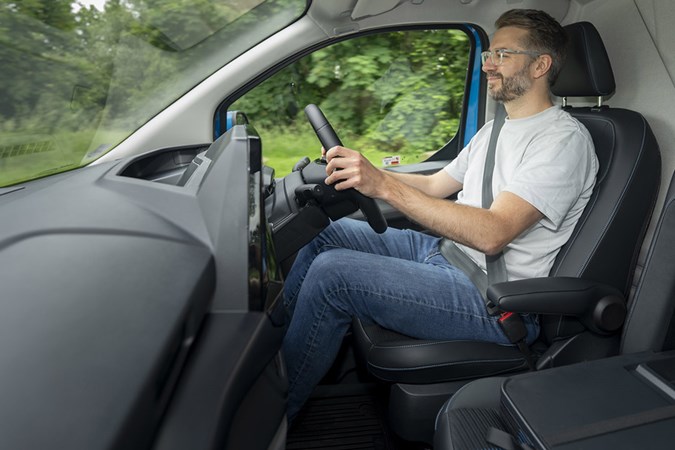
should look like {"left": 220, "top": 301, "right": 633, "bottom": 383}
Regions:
{"left": 0, "top": 0, "right": 470, "bottom": 186}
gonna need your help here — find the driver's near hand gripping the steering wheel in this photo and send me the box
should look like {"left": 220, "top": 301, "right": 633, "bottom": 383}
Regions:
{"left": 326, "top": 146, "right": 386, "bottom": 198}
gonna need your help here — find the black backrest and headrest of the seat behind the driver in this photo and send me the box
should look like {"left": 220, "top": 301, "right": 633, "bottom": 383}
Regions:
{"left": 543, "top": 22, "right": 661, "bottom": 339}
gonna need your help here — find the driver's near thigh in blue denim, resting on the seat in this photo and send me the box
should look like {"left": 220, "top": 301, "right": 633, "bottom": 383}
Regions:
{"left": 303, "top": 249, "right": 506, "bottom": 343}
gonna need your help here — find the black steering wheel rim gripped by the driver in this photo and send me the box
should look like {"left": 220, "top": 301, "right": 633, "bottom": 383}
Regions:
{"left": 305, "top": 104, "right": 387, "bottom": 233}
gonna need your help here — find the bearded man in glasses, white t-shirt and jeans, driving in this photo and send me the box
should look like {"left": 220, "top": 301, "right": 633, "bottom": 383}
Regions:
{"left": 283, "top": 10, "right": 597, "bottom": 420}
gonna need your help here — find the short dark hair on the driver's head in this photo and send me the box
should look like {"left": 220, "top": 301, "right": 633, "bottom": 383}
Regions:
{"left": 495, "top": 9, "right": 568, "bottom": 86}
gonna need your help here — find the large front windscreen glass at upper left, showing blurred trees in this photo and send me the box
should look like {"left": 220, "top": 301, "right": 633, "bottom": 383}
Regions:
{"left": 0, "top": 0, "right": 307, "bottom": 186}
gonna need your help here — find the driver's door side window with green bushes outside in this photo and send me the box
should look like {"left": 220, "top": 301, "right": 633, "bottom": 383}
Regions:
{"left": 229, "top": 29, "right": 471, "bottom": 176}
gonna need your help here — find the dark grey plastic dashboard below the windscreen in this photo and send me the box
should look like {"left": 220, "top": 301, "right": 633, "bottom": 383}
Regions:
{"left": 0, "top": 125, "right": 285, "bottom": 449}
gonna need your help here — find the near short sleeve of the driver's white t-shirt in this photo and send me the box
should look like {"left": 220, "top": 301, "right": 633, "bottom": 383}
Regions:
{"left": 502, "top": 132, "right": 597, "bottom": 230}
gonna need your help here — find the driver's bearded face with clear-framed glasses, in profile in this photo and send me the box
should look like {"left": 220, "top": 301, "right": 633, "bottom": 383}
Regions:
{"left": 483, "top": 27, "right": 533, "bottom": 102}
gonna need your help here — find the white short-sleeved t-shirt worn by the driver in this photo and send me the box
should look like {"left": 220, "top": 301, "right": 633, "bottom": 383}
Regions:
{"left": 444, "top": 106, "right": 598, "bottom": 280}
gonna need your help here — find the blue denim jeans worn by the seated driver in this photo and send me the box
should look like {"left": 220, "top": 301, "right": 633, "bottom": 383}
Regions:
{"left": 283, "top": 219, "right": 538, "bottom": 420}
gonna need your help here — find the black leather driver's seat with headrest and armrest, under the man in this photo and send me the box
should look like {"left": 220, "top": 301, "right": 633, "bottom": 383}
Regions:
{"left": 353, "top": 22, "right": 661, "bottom": 442}
